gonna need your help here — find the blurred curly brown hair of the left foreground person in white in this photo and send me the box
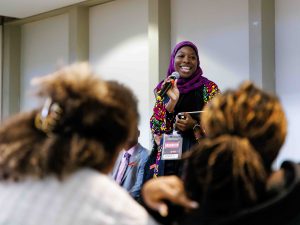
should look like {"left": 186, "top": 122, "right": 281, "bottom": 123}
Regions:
{"left": 0, "top": 63, "right": 139, "bottom": 180}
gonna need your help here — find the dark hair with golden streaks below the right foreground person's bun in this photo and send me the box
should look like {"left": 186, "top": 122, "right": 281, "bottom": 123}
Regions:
{"left": 184, "top": 135, "right": 266, "bottom": 213}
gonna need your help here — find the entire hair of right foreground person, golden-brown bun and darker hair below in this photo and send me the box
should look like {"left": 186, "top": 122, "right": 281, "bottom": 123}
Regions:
{"left": 183, "top": 82, "right": 287, "bottom": 222}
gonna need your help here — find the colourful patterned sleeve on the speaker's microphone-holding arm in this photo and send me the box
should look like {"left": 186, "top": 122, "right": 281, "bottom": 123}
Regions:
{"left": 150, "top": 97, "right": 174, "bottom": 136}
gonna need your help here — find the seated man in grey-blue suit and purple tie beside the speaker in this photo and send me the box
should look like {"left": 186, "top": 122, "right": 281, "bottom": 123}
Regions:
{"left": 112, "top": 127, "right": 149, "bottom": 202}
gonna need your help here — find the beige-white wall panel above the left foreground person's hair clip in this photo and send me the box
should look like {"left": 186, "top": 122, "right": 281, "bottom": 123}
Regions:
{"left": 20, "top": 14, "right": 69, "bottom": 111}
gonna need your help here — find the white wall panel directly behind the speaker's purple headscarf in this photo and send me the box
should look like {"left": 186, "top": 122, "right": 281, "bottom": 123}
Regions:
{"left": 171, "top": 0, "right": 249, "bottom": 90}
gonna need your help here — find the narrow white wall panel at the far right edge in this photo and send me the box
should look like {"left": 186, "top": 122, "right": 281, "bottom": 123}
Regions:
{"left": 275, "top": 0, "right": 300, "bottom": 163}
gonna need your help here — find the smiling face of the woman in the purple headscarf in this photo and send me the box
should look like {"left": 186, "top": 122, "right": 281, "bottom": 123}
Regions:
{"left": 174, "top": 46, "right": 198, "bottom": 78}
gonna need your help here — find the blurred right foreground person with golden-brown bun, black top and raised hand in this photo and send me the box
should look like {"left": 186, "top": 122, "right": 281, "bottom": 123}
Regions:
{"left": 144, "top": 82, "right": 300, "bottom": 225}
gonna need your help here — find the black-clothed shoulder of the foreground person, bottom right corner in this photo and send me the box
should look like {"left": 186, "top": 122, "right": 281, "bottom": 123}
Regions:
{"left": 225, "top": 161, "right": 300, "bottom": 225}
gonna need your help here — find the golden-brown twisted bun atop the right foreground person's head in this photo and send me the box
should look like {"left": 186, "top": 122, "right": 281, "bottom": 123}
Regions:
{"left": 201, "top": 82, "right": 287, "bottom": 170}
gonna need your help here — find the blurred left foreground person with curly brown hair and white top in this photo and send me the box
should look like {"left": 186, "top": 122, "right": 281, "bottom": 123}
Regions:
{"left": 0, "top": 64, "right": 156, "bottom": 225}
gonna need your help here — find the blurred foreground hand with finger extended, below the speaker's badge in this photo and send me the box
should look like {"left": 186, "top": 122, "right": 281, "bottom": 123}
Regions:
{"left": 142, "top": 176, "right": 198, "bottom": 216}
